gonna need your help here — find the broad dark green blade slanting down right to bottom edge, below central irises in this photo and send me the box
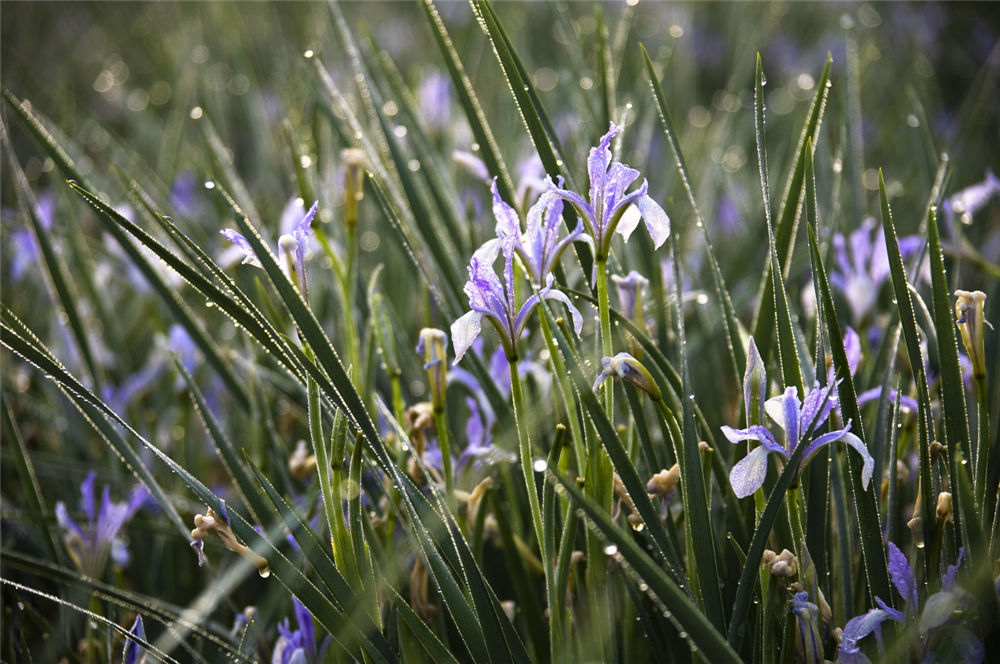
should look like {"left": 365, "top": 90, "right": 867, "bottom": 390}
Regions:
{"left": 548, "top": 466, "right": 744, "bottom": 662}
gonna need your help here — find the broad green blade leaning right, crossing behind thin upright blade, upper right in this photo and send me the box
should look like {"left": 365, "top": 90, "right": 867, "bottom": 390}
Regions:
{"left": 753, "top": 55, "right": 833, "bottom": 357}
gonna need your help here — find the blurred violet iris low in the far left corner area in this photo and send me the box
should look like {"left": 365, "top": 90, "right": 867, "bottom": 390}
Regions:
{"left": 56, "top": 470, "right": 149, "bottom": 579}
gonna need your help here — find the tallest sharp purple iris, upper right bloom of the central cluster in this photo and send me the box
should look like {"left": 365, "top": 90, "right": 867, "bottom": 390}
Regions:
{"left": 547, "top": 122, "right": 670, "bottom": 257}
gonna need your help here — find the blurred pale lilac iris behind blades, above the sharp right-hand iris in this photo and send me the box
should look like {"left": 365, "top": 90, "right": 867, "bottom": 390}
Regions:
{"left": 830, "top": 217, "right": 930, "bottom": 323}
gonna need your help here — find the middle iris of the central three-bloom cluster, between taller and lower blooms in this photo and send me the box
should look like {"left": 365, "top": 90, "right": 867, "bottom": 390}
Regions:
{"left": 491, "top": 178, "right": 594, "bottom": 284}
